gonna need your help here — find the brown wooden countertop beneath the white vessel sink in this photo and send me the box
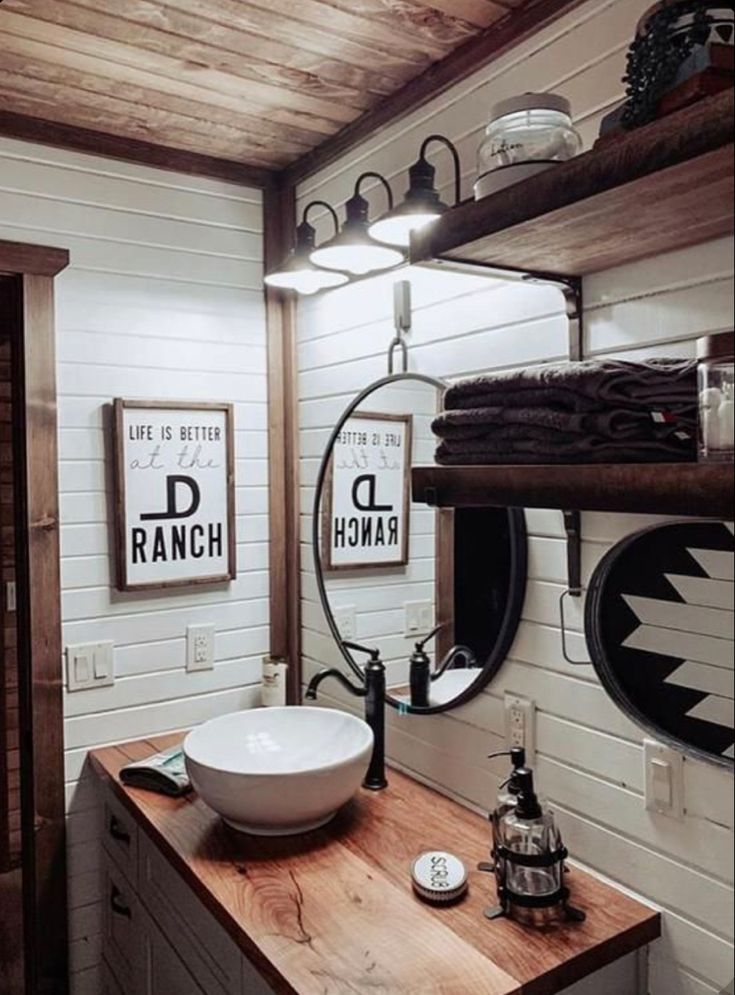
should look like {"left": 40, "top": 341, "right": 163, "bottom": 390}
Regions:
{"left": 91, "top": 734, "right": 661, "bottom": 995}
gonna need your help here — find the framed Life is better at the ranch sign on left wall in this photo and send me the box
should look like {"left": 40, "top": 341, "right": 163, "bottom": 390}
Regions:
{"left": 114, "top": 399, "right": 237, "bottom": 591}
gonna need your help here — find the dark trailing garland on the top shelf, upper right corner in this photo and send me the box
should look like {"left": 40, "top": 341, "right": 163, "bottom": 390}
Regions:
{"left": 622, "top": 0, "right": 735, "bottom": 129}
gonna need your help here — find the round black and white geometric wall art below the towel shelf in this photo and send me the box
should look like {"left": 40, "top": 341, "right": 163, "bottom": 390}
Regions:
{"left": 586, "top": 521, "right": 735, "bottom": 769}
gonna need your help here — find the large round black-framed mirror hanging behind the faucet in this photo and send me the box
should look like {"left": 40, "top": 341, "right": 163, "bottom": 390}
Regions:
{"left": 312, "top": 373, "right": 528, "bottom": 715}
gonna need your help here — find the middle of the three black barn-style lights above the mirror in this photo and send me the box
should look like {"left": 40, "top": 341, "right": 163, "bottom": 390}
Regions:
{"left": 311, "top": 172, "right": 404, "bottom": 276}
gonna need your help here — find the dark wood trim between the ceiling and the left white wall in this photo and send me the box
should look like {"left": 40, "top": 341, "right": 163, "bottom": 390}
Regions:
{"left": 0, "top": 111, "right": 277, "bottom": 191}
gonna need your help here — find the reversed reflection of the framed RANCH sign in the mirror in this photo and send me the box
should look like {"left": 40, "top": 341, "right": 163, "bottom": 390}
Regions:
{"left": 322, "top": 412, "right": 413, "bottom": 573}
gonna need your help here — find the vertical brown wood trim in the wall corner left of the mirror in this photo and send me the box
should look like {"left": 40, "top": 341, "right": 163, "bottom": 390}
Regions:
{"left": 264, "top": 186, "right": 302, "bottom": 704}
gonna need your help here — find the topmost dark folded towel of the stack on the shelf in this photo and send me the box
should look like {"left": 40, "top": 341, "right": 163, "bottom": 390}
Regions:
{"left": 445, "top": 359, "right": 697, "bottom": 417}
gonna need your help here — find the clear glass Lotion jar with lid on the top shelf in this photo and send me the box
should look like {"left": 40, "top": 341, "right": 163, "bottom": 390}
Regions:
{"left": 475, "top": 93, "right": 582, "bottom": 200}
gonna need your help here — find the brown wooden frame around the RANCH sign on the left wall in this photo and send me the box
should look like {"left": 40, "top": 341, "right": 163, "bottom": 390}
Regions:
{"left": 112, "top": 397, "right": 237, "bottom": 592}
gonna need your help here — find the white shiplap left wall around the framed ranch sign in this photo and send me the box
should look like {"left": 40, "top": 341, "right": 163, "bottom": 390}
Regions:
{"left": 0, "top": 139, "right": 268, "bottom": 995}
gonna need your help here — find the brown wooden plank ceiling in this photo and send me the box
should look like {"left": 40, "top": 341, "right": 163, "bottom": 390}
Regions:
{"left": 0, "top": 0, "right": 540, "bottom": 170}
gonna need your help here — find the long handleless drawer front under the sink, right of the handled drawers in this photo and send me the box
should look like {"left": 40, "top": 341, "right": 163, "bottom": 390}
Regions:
{"left": 138, "top": 834, "right": 242, "bottom": 995}
